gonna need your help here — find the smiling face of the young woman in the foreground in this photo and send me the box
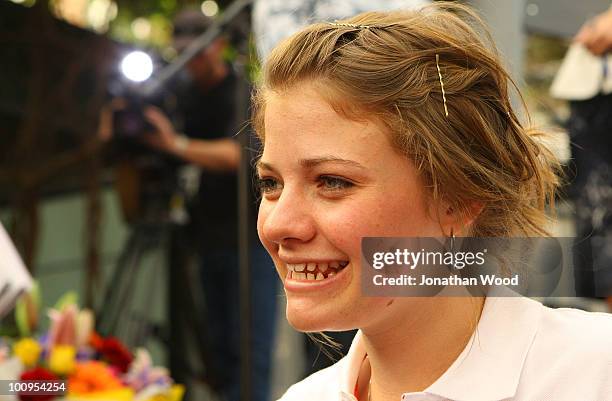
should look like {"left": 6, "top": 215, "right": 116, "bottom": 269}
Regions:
{"left": 258, "top": 83, "right": 452, "bottom": 331}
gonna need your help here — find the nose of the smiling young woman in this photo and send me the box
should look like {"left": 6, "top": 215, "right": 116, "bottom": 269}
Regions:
{"left": 259, "top": 186, "right": 316, "bottom": 245}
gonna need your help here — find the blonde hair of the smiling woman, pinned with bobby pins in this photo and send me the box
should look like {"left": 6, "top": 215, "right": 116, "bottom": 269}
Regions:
{"left": 254, "top": 3, "right": 559, "bottom": 237}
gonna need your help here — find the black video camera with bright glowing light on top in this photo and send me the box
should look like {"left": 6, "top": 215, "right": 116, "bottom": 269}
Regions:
{"left": 107, "top": 50, "right": 188, "bottom": 223}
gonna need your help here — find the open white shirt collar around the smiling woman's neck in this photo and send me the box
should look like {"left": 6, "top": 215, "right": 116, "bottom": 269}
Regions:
{"left": 340, "top": 296, "right": 542, "bottom": 401}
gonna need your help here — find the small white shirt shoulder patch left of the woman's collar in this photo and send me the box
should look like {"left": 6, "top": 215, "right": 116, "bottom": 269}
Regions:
{"left": 278, "top": 358, "right": 346, "bottom": 401}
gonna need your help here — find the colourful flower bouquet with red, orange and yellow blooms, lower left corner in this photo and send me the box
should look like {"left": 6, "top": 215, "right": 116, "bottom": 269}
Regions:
{"left": 0, "top": 290, "right": 184, "bottom": 401}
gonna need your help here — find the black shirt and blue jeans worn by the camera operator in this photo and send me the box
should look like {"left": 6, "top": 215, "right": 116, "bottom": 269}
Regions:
{"left": 179, "top": 68, "right": 277, "bottom": 401}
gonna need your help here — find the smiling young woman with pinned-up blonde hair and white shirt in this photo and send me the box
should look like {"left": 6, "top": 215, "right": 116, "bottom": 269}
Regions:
{"left": 254, "top": 4, "right": 612, "bottom": 401}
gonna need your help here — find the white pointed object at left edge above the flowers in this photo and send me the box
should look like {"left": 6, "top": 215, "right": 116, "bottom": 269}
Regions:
{"left": 0, "top": 224, "right": 32, "bottom": 318}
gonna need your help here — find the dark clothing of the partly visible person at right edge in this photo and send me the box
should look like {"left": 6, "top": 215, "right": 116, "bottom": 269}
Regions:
{"left": 568, "top": 95, "right": 612, "bottom": 298}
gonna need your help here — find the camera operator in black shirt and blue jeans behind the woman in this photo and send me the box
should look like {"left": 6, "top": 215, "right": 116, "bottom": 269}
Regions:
{"left": 143, "top": 10, "right": 277, "bottom": 401}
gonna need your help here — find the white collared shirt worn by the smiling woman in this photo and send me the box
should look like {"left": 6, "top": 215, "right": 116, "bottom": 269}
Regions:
{"left": 281, "top": 297, "right": 612, "bottom": 401}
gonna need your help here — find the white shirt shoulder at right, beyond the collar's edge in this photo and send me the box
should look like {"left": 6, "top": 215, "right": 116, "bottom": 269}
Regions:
{"left": 519, "top": 306, "right": 612, "bottom": 400}
